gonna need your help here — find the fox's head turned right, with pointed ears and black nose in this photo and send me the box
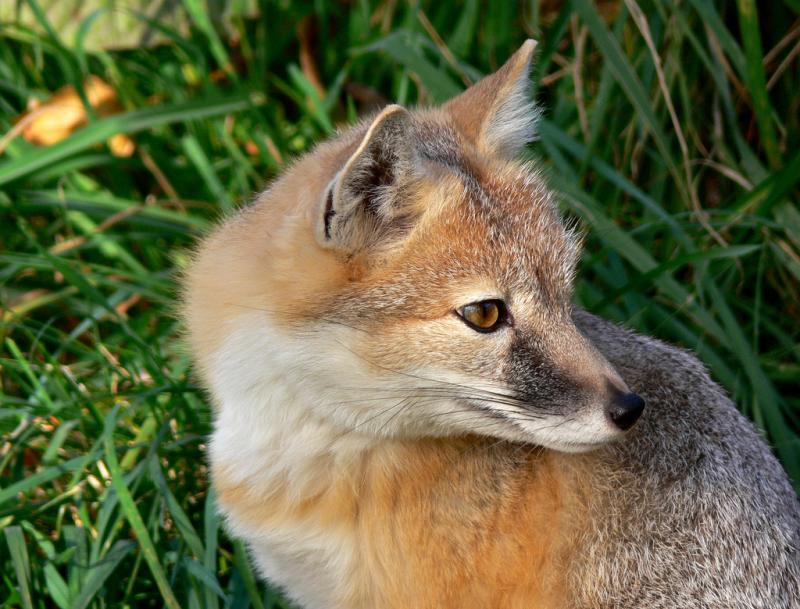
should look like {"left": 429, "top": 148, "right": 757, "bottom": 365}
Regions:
{"left": 186, "top": 41, "right": 644, "bottom": 451}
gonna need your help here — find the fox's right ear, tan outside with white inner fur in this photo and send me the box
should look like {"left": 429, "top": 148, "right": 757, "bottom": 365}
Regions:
{"left": 444, "top": 39, "right": 539, "bottom": 157}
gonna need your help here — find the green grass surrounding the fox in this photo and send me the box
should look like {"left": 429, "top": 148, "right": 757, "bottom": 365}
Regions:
{"left": 0, "top": 0, "right": 800, "bottom": 609}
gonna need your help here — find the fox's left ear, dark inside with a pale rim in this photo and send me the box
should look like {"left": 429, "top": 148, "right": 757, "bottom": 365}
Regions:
{"left": 317, "top": 105, "right": 415, "bottom": 254}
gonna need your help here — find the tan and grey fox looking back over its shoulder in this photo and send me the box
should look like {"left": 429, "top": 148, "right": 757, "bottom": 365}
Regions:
{"left": 183, "top": 40, "right": 800, "bottom": 609}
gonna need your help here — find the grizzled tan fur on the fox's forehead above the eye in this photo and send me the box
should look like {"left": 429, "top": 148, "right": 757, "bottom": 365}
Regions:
{"left": 374, "top": 161, "right": 580, "bottom": 306}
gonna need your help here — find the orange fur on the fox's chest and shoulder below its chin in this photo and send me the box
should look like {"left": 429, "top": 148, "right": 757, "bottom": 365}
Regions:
{"left": 214, "top": 438, "right": 586, "bottom": 609}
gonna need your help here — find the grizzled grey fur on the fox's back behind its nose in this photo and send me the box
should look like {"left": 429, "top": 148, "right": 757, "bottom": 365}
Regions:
{"left": 571, "top": 311, "right": 800, "bottom": 609}
